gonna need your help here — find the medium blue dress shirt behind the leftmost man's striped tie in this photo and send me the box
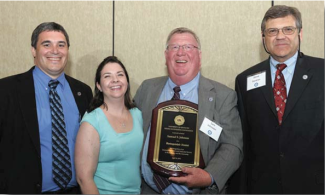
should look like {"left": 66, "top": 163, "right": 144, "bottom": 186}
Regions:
{"left": 33, "top": 67, "right": 81, "bottom": 192}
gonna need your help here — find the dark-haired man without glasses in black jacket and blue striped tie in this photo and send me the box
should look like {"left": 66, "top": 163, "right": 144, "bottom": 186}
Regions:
{"left": 0, "top": 22, "right": 92, "bottom": 194}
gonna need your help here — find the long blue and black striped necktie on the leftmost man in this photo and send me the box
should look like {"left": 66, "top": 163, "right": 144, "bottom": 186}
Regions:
{"left": 49, "top": 80, "right": 72, "bottom": 189}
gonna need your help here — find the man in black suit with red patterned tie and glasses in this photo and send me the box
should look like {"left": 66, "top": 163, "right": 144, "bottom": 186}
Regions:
{"left": 228, "top": 5, "right": 324, "bottom": 194}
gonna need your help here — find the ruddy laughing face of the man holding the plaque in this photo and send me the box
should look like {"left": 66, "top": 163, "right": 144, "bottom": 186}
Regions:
{"left": 165, "top": 33, "right": 201, "bottom": 86}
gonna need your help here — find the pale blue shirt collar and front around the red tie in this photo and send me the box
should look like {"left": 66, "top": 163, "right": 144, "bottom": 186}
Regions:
{"left": 270, "top": 52, "right": 298, "bottom": 97}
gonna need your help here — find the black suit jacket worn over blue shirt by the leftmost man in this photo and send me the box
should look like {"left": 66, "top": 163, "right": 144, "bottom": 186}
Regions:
{"left": 0, "top": 68, "right": 92, "bottom": 194}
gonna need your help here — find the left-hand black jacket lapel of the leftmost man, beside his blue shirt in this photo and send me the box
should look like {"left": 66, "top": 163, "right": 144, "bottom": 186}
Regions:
{"left": 17, "top": 68, "right": 41, "bottom": 155}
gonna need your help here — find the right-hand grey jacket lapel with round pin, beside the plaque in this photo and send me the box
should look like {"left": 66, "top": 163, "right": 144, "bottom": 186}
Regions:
{"left": 198, "top": 75, "right": 216, "bottom": 162}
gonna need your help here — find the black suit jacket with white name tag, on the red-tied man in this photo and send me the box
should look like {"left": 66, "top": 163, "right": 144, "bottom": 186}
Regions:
{"left": 228, "top": 56, "right": 324, "bottom": 194}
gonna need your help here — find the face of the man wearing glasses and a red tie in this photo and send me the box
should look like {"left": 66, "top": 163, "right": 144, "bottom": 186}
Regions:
{"left": 264, "top": 15, "right": 302, "bottom": 62}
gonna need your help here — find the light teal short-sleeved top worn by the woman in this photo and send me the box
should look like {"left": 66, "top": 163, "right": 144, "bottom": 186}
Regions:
{"left": 81, "top": 108, "right": 143, "bottom": 194}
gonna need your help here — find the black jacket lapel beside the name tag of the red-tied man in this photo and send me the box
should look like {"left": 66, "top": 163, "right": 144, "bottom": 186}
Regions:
{"left": 261, "top": 58, "right": 278, "bottom": 117}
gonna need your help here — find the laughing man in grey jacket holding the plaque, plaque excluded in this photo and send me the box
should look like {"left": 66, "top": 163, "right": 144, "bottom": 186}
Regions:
{"left": 134, "top": 28, "right": 243, "bottom": 194}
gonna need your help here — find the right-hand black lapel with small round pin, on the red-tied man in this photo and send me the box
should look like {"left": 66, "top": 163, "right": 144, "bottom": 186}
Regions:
{"left": 283, "top": 58, "right": 313, "bottom": 121}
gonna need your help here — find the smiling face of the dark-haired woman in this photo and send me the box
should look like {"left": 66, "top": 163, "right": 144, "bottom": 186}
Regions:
{"left": 96, "top": 62, "right": 128, "bottom": 100}
